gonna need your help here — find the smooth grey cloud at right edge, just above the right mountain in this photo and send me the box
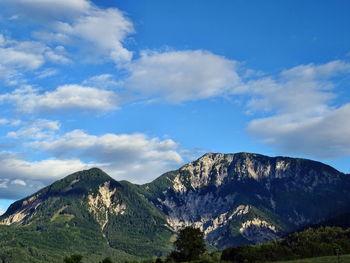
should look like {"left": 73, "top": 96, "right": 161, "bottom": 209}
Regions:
{"left": 248, "top": 104, "right": 350, "bottom": 158}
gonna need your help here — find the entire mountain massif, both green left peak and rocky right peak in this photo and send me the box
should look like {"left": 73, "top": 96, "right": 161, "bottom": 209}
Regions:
{"left": 0, "top": 153, "right": 350, "bottom": 262}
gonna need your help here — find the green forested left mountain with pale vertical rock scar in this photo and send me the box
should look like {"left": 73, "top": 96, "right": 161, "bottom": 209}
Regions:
{"left": 0, "top": 168, "right": 172, "bottom": 263}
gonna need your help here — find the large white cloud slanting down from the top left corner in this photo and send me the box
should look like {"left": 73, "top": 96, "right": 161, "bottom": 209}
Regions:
{"left": 3, "top": 0, "right": 134, "bottom": 65}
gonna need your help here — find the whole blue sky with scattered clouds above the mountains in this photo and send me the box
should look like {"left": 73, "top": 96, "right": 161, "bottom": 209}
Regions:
{"left": 0, "top": 0, "right": 350, "bottom": 214}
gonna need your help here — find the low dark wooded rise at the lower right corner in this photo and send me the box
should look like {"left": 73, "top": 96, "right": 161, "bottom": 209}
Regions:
{"left": 221, "top": 227, "right": 350, "bottom": 263}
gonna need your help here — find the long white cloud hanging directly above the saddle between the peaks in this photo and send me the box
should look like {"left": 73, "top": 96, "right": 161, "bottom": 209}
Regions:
{"left": 28, "top": 130, "right": 183, "bottom": 183}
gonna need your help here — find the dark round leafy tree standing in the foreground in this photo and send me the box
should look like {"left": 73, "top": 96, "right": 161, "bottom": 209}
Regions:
{"left": 170, "top": 227, "right": 206, "bottom": 262}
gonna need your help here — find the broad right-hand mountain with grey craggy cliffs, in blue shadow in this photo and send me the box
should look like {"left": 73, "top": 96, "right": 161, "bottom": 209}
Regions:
{"left": 145, "top": 153, "right": 350, "bottom": 248}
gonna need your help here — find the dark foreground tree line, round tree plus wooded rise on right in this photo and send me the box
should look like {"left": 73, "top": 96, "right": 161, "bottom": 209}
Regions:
{"left": 64, "top": 227, "right": 350, "bottom": 263}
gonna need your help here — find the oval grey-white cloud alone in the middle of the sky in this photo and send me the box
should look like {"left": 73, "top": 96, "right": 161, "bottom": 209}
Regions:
{"left": 125, "top": 50, "right": 240, "bottom": 103}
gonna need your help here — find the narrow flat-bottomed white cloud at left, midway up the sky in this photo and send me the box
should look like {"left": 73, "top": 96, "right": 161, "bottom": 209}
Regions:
{"left": 0, "top": 85, "right": 118, "bottom": 113}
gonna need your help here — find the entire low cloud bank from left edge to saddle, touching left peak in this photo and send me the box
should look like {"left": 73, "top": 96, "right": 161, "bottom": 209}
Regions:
{"left": 0, "top": 127, "right": 183, "bottom": 199}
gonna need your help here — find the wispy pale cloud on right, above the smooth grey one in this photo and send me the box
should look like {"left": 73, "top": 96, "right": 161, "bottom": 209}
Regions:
{"left": 238, "top": 61, "right": 350, "bottom": 117}
